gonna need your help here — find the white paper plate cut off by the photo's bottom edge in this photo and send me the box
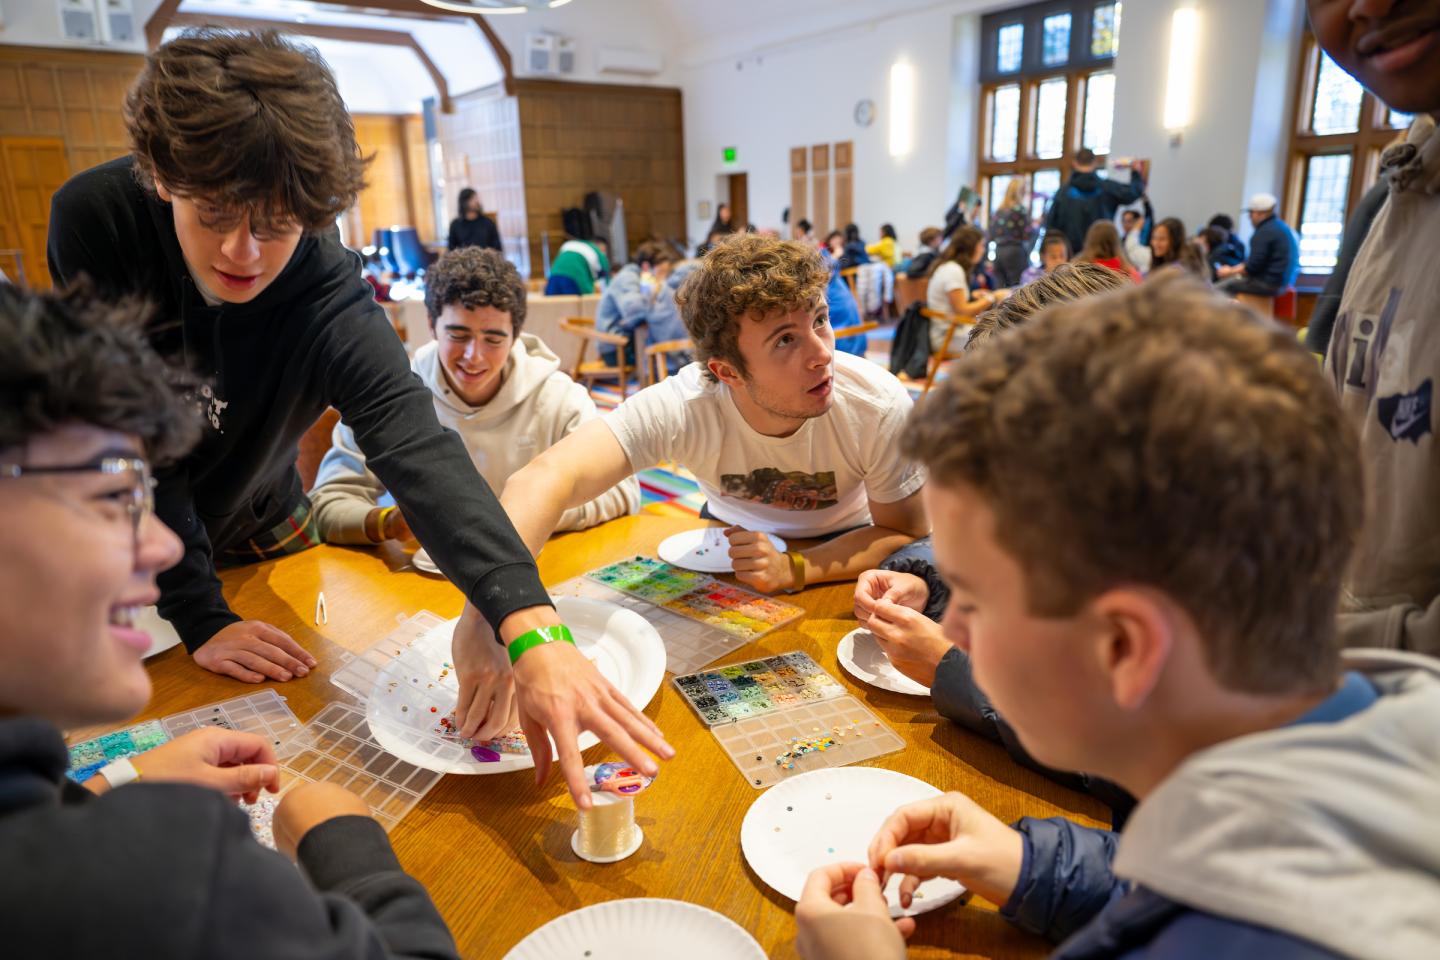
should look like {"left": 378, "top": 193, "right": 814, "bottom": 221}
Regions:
{"left": 504, "top": 898, "right": 765, "bottom": 960}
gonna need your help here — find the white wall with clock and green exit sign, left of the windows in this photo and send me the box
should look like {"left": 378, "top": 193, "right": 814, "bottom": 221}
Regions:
{"left": 681, "top": 1, "right": 981, "bottom": 248}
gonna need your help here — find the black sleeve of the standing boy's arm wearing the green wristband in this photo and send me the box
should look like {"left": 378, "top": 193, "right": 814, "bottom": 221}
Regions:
{"left": 314, "top": 272, "right": 550, "bottom": 633}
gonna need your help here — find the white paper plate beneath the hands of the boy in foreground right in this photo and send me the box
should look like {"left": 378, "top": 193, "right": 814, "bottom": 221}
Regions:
{"left": 740, "top": 767, "right": 965, "bottom": 917}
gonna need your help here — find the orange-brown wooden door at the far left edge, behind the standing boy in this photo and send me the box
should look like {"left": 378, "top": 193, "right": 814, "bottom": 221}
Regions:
{"left": 0, "top": 137, "right": 71, "bottom": 289}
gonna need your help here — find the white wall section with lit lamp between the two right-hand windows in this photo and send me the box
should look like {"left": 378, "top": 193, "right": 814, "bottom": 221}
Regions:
{"left": 1112, "top": 0, "right": 1302, "bottom": 233}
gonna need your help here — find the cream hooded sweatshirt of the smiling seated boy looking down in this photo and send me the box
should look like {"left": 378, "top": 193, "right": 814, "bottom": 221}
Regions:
{"left": 310, "top": 334, "right": 639, "bottom": 544}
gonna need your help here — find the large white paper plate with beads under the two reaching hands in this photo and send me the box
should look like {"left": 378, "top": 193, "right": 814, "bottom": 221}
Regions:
{"left": 366, "top": 597, "right": 665, "bottom": 774}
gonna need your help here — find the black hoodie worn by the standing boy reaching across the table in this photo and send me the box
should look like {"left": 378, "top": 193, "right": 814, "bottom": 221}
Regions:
{"left": 49, "top": 157, "right": 550, "bottom": 652}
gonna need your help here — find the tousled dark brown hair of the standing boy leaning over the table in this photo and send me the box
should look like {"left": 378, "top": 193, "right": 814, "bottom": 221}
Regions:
{"left": 125, "top": 29, "right": 369, "bottom": 232}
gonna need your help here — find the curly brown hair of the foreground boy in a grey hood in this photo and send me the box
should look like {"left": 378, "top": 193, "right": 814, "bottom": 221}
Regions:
{"left": 901, "top": 271, "right": 1362, "bottom": 694}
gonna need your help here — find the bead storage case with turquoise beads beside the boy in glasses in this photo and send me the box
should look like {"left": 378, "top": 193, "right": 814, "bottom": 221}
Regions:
{"left": 68, "top": 689, "right": 300, "bottom": 783}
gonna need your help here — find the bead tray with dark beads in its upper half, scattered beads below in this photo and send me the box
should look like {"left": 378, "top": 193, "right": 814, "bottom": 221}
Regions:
{"left": 674, "top": 651, "right": 904, "bottom": 790}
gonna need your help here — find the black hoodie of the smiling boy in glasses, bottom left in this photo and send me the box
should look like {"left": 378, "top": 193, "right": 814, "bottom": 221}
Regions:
{"left": 0, "top": 717, "right": 458, "bottom": 960}
